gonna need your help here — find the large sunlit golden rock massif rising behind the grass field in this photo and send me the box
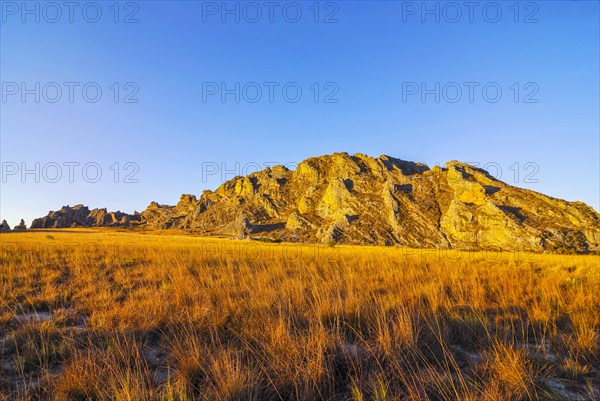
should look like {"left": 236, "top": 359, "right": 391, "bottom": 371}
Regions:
{"left": 29, "top": 153, "right": 600, "bottom": 252}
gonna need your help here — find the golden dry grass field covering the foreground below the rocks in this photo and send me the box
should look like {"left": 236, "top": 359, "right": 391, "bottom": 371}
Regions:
{"left": 0, "top": 230, "right": 600, "bottom": 401}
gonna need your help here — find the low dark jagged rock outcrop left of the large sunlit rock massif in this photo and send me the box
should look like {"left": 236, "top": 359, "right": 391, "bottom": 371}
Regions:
{"left": 31, "top": 205, "right": 142, "bottom": 228}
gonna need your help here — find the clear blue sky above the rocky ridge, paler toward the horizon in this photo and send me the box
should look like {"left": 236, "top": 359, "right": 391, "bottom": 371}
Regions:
{"left": 0, "top": 1, "right": 600, "bottom": 225}
